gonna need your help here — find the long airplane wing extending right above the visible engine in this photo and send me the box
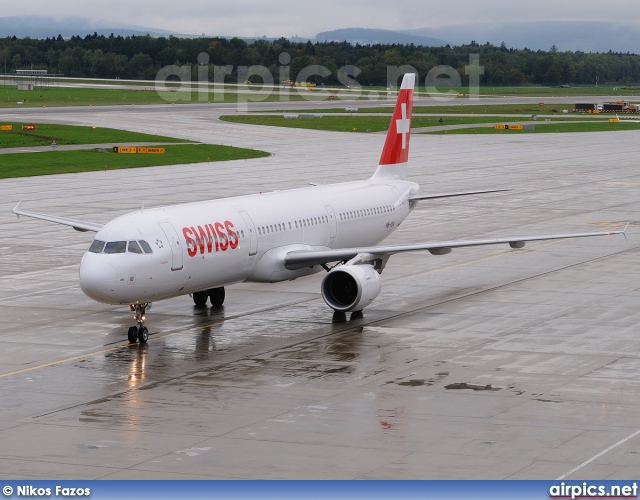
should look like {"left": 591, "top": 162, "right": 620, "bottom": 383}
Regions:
{"left": 284, "top": 229, "right": 628, "bottom": 270}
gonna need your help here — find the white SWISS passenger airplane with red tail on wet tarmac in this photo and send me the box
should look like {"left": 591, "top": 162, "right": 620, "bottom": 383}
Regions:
{"left": 13, "top": 73, "right": 626, "bottom": 343}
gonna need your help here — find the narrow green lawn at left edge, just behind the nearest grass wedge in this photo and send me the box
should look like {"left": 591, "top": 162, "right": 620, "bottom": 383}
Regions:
{"left": 0, "top": 122, "right": 190, "bottom": 148}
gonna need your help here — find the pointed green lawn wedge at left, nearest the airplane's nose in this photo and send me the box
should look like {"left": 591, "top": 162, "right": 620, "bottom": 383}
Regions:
{"left": 0, "top": 144, "right": 269, "bottom": 179}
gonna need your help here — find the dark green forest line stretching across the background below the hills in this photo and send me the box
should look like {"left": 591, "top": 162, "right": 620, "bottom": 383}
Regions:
{"left": 0, "top": 33, "right": 640, "bottom": 86}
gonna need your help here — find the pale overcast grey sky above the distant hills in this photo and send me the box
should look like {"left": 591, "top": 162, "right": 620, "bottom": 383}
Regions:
{"left": 0, "top": 0, "right": 640, "bottom": 38}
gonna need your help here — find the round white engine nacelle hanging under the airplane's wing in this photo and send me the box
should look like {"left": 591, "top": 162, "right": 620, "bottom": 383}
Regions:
{"left": 321, "top": 264, "right": 382, "bottom": 312}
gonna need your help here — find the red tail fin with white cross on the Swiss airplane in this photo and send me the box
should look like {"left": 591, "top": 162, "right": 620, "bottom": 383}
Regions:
{"left": 375, "top": 73, "right": 416, "bottom": 179}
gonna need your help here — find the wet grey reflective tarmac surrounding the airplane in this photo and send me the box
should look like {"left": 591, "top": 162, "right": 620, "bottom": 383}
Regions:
{"left": 0, "top": 100, "right": 640, "bottom": 479}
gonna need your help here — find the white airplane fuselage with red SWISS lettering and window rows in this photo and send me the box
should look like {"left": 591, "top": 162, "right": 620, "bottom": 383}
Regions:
{"left": 80, "top": 176, "right": 418, "bottom": 304}
